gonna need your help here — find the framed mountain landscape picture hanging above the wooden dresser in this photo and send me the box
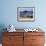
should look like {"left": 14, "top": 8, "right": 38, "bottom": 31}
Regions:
{"left": 17, "top": 7, "right": 35, "bottom": 22}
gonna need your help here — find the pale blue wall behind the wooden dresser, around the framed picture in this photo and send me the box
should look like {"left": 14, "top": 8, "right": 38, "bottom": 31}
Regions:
{"left": 0, "top": 0, "right": 46, "bottom": 28}
